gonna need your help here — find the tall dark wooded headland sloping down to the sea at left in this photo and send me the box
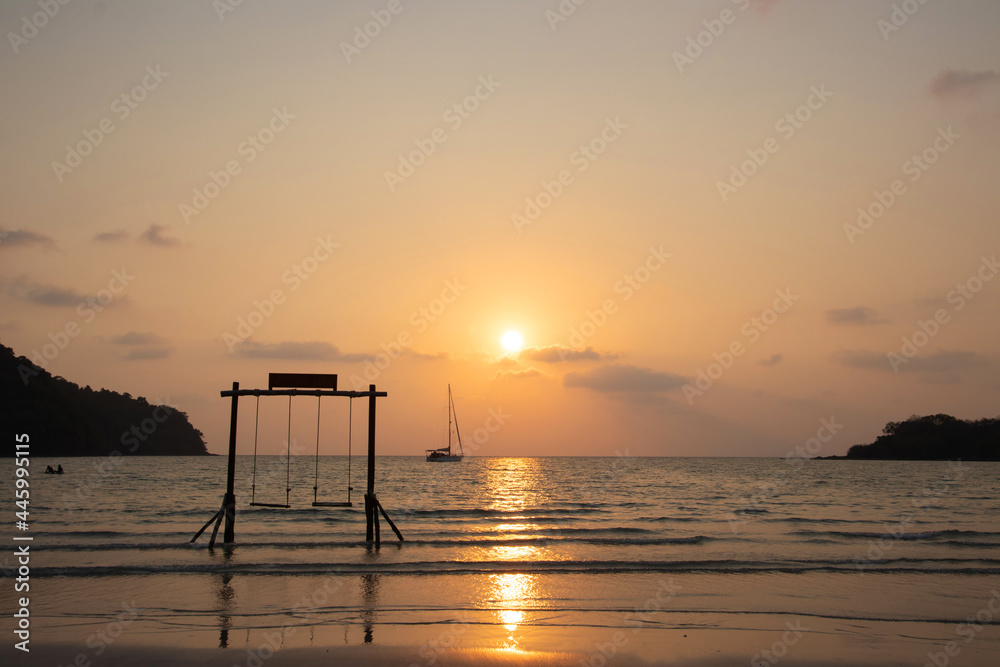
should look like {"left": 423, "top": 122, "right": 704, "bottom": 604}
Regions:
{"left": 0, "top": 344, "right": 209, "bottom": 456}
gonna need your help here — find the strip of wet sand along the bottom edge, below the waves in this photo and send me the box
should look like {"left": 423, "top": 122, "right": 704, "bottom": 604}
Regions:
{"left": 7, "top": 616, "right": 1000, "bottom": 667}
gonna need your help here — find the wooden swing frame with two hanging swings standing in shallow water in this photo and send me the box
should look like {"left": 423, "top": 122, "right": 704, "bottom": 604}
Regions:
{"left": 191, "top": 373, "right": 403, "bottom": 548}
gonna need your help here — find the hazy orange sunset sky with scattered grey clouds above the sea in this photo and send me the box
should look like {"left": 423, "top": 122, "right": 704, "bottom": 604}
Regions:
{"left": 0, "top": 0, "right": 1000, "bottom": 456}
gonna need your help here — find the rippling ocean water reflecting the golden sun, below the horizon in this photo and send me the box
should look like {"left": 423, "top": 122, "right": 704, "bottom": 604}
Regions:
{"left": 0, "top": 456, "right": 1000, "bottom": 665}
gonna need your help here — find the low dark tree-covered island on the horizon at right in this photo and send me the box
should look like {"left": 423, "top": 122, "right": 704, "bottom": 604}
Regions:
{"left": 819, "top": 414, "right": 1000, "bottom": 461}
